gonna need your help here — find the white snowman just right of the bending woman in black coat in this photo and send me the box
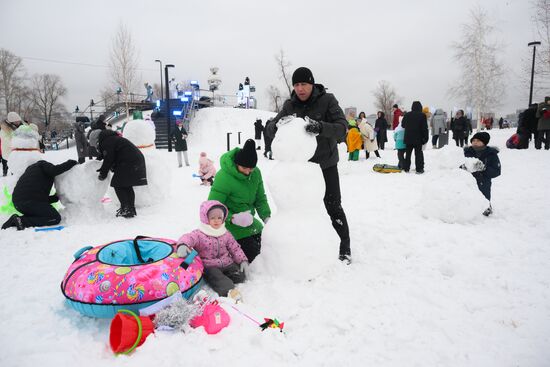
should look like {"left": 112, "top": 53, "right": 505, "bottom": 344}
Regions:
{"left": 122, "top": 117, "right": 171, "bottom": 207}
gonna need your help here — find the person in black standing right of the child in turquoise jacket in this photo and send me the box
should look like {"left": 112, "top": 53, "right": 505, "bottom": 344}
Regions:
{"left": 401, "top": 101, "right": 429, "bottom": 174}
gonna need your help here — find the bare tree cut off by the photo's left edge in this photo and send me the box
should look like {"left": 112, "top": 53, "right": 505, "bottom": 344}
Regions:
{"left": 0, "top": 48, "right": 24, "bottom": 113}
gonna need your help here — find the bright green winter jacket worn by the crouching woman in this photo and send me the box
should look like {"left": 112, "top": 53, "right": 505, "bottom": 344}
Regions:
{"left": 208, "top": 148, "right": 271, "bottom": 240}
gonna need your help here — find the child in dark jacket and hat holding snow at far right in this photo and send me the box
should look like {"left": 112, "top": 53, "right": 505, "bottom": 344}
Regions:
{"left": 460, "top": 132, "right": 500, "bottom": 217}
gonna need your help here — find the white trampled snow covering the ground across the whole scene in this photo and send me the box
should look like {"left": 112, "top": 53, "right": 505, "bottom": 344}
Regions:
{"left": 0, "top": 108, "right": 550, "bottom": 367}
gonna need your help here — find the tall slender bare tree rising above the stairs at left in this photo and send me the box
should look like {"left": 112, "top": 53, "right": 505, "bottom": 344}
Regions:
{"left": 109, "top": 23, "right": 141, "bottom": 121}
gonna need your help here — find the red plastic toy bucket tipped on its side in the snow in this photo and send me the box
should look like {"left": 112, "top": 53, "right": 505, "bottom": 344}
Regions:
{"left": 109, "top": 310, "right": 155, "bottom": 354}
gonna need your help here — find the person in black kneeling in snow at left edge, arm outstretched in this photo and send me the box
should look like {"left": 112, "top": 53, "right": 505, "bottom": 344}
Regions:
{"left": 2, "top": 159, "right": 77, "bottom": 231}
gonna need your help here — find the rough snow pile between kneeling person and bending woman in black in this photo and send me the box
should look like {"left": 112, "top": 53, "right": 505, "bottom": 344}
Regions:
{"left": 55, "top": 160, "right": 111, "bottom": 224}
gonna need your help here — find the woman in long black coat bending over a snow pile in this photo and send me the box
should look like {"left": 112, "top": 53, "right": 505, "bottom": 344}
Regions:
{"left": 98, "top": 130, "right": 147, "bottom": 218}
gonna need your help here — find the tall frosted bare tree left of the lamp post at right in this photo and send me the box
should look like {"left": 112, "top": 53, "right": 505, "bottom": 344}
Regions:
{"left": 450, "top": 6, "right": 506, "bottom": 130}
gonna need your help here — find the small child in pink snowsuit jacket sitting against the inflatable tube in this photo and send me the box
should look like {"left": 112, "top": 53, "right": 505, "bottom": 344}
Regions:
{"left": 177, "top": 200, "right": 248, "bottom": 297}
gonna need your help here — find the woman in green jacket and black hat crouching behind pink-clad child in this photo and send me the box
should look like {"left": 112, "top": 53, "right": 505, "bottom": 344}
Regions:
{"left": 208, "top": 139, "right": 271, "bottom": 262}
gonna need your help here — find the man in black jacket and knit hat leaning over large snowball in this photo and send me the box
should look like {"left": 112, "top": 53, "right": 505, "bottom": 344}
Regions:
{"left": 264, "top": 67, "right": 351, "bottom": 264}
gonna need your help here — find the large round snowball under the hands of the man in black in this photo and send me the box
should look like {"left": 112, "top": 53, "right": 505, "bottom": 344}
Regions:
{"left": 271, "top": 118, "right": 317, "bottom": 162}
